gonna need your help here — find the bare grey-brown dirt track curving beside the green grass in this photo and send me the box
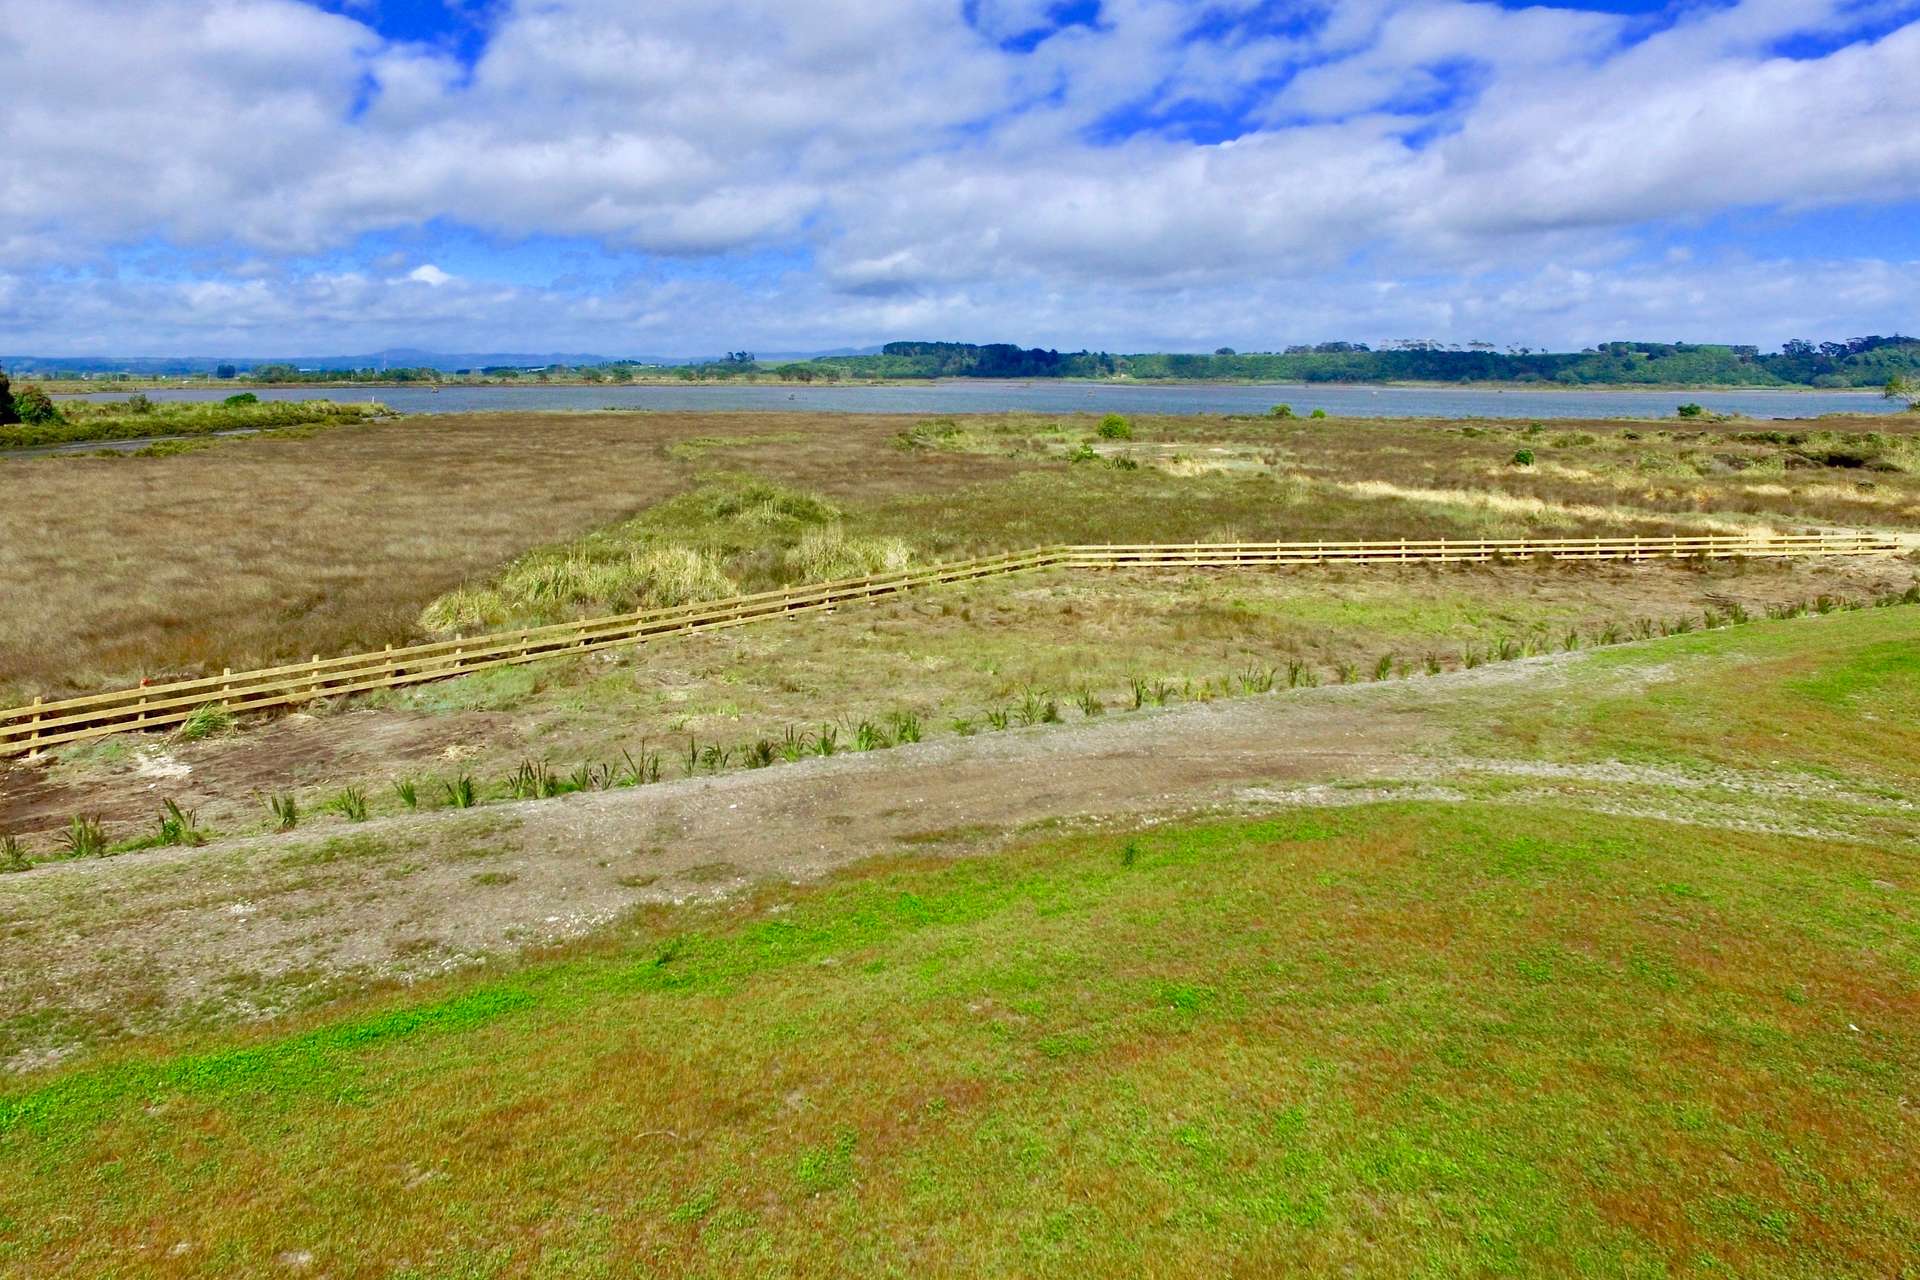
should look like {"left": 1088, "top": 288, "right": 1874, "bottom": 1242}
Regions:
{"left": 0, "top": 637, "right": 1904, "bottom": 1069}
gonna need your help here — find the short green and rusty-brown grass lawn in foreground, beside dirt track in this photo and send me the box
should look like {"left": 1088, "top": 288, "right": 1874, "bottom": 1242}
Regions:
{"left": 0, "top": 610, "right": 1920, "bottom": 1276}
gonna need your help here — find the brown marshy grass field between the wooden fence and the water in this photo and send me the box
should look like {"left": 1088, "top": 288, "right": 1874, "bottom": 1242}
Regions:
{"left": 0, "top": 413, "right": 1920, "bottom": 700}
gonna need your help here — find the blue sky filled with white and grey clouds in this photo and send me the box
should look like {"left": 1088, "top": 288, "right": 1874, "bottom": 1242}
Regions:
{"left": 0, "top": 0, "right": 1920, "bottom": 357}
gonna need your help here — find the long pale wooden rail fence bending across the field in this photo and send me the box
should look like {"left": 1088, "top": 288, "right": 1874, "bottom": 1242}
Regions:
{"left": 0, "top": 533, "right": 1908, "bottom": 756}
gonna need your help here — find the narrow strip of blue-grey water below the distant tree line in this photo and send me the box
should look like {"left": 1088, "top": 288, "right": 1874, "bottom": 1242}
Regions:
{"left": 52, "top": 382, "right": 1895, "bottom": 418}
